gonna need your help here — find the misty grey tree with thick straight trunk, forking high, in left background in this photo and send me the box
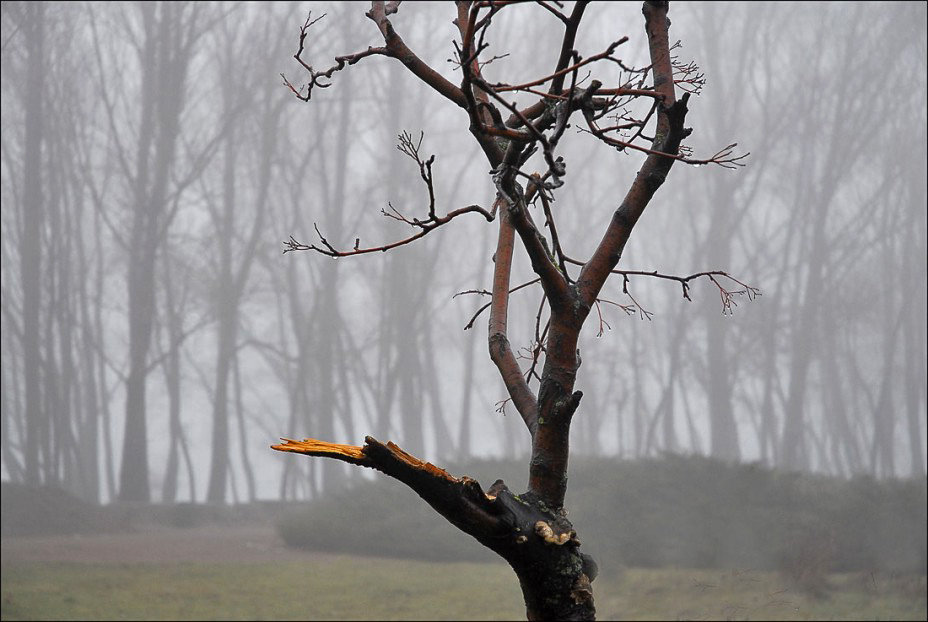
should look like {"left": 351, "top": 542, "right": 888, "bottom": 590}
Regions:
{"left": 89, "top": 3, "right": 215, "bottom": 501}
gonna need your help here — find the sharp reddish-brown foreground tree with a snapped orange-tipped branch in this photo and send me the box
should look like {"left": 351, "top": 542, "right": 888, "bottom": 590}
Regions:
{"left": 273, "top": 1, "right": 757, "bottom": 620}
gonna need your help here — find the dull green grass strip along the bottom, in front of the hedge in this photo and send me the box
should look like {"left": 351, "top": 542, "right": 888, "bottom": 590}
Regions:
{"left": 0, "top": 556, "right": 926, "bottom": 620}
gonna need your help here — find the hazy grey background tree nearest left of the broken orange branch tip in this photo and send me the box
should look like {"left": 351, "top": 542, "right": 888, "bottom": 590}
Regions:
{"left": 203, "top": 6, "right": 285, "bottom": 503}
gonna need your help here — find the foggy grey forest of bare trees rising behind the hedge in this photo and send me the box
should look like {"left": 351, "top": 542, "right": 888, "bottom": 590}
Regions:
{"left": 0, "top": 2, "right": 928, "bottom": 619}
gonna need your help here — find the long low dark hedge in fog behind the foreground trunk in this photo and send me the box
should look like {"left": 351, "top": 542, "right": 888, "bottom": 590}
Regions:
{"left": 278, "top": 455, "right": 928, "bottom": 576}
